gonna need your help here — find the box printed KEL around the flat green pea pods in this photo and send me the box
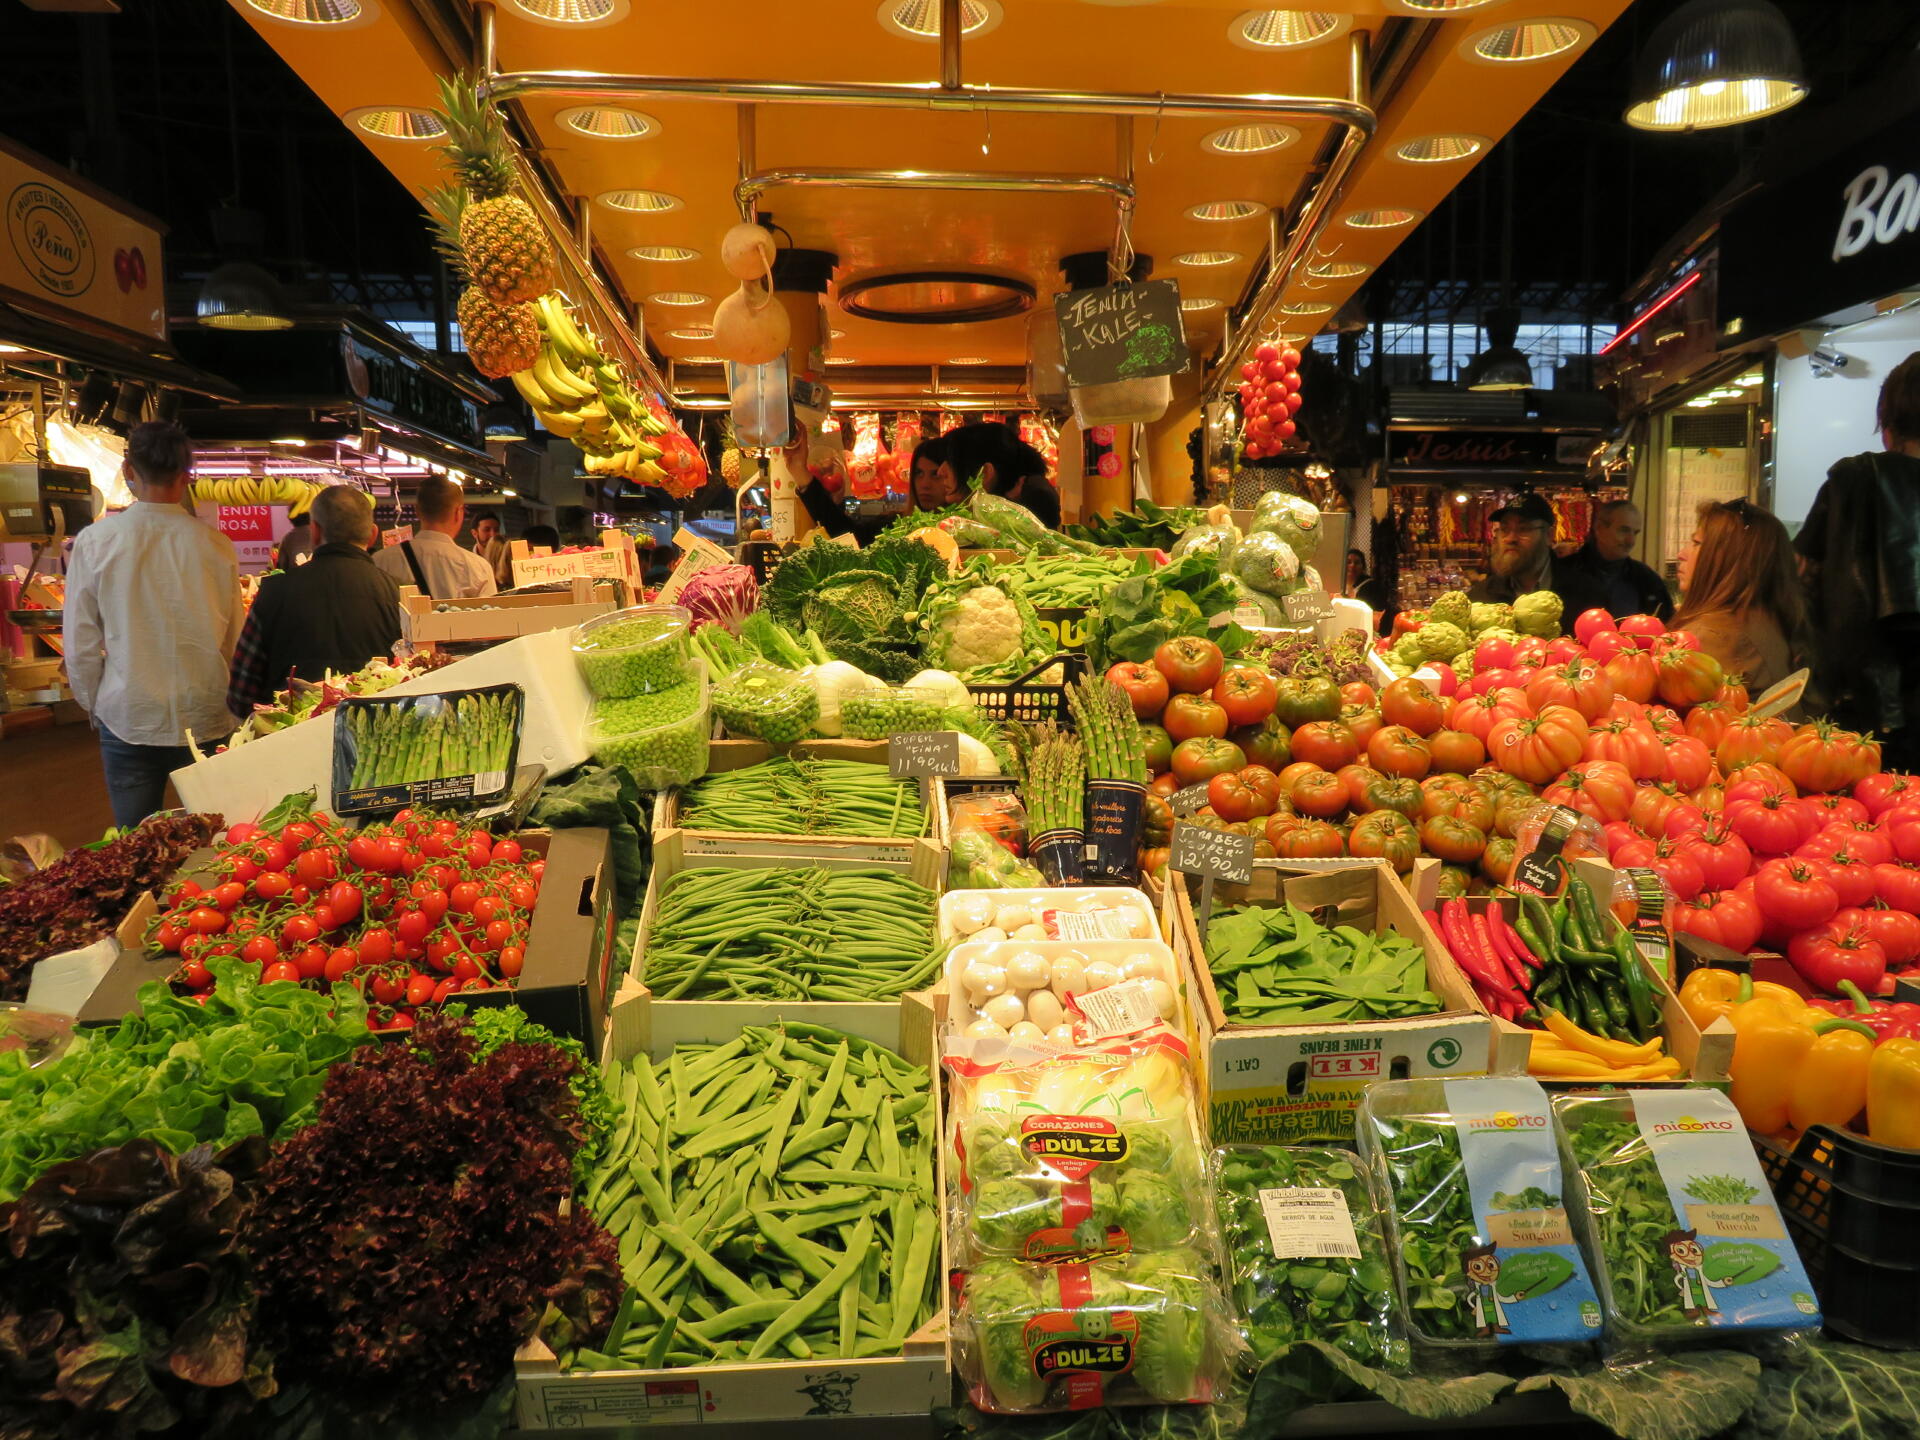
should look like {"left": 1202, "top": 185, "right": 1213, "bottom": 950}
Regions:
{"left": 1164, "top": 860, "right": 1492, "bottom": 1144}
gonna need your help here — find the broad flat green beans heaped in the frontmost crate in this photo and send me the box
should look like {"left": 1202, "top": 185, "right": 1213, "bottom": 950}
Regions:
{"left": 563, "top": 1021, "right": 943, "bottom": 1369}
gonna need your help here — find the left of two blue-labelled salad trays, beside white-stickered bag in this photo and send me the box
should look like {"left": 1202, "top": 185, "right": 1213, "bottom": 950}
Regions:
{"left": 1359, "top": 1075, "right": 1601, "bottom": 1348}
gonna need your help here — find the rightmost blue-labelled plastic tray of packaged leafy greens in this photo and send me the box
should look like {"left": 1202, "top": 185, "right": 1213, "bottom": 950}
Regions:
{"left": 1553, "top": 1089, "right": 1820, "bottom": 1348}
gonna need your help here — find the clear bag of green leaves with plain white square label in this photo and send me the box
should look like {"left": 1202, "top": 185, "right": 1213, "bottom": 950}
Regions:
{"left": 1212, "top": 1144, "right": 1409, "bottom": 1369}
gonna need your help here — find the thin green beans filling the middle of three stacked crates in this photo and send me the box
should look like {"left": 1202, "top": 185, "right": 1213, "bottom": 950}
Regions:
{"left": 641, "top": 864, "right": 947, "bottom": 1000}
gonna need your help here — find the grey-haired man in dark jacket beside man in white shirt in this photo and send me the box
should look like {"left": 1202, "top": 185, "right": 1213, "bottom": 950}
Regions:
{"left": 227, "top": 486, "right": 399, "bottom": 718}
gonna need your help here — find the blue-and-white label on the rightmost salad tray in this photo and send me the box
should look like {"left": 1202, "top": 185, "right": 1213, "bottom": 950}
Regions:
{"left": 1630, "top": 1089, "right": 1818, "bottom": 1329}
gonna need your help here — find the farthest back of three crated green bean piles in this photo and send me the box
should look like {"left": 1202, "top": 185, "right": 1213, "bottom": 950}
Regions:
{"left": 680, "top": 756, "right": 927, "bottom": 839}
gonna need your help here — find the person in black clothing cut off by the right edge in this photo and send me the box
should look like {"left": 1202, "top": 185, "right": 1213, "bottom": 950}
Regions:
{"left": 1793, "top": 351, "right": 1920, "bottom": 770}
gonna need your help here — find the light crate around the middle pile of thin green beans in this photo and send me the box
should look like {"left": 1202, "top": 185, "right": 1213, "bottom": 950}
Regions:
{"left": 609, "top": 829, "right": 947, "bottom": 1054}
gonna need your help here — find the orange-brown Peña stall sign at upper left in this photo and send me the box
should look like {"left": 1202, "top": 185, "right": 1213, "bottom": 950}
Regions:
{"left": 0, "top": 140, "right": 167, "bottom": 342}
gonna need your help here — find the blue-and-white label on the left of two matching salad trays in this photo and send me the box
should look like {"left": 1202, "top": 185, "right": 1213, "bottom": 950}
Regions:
{"left": 1446, "top": 1075, "right": 1599, "bottom": 1344}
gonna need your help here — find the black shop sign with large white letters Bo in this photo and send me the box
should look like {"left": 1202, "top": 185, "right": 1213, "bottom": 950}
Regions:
{"left": 1716, "top": 98, "right": 1920, "bottom": 340}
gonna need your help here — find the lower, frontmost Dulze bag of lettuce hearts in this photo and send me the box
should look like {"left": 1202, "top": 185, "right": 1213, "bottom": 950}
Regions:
{"left": 956, "top": 1250, "right": 1227, "bottom": 1413}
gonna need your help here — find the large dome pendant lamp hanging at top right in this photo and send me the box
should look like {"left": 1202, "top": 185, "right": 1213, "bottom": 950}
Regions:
{"left": 1622, "top": 0, "right": 1807, "bottom": 131}
